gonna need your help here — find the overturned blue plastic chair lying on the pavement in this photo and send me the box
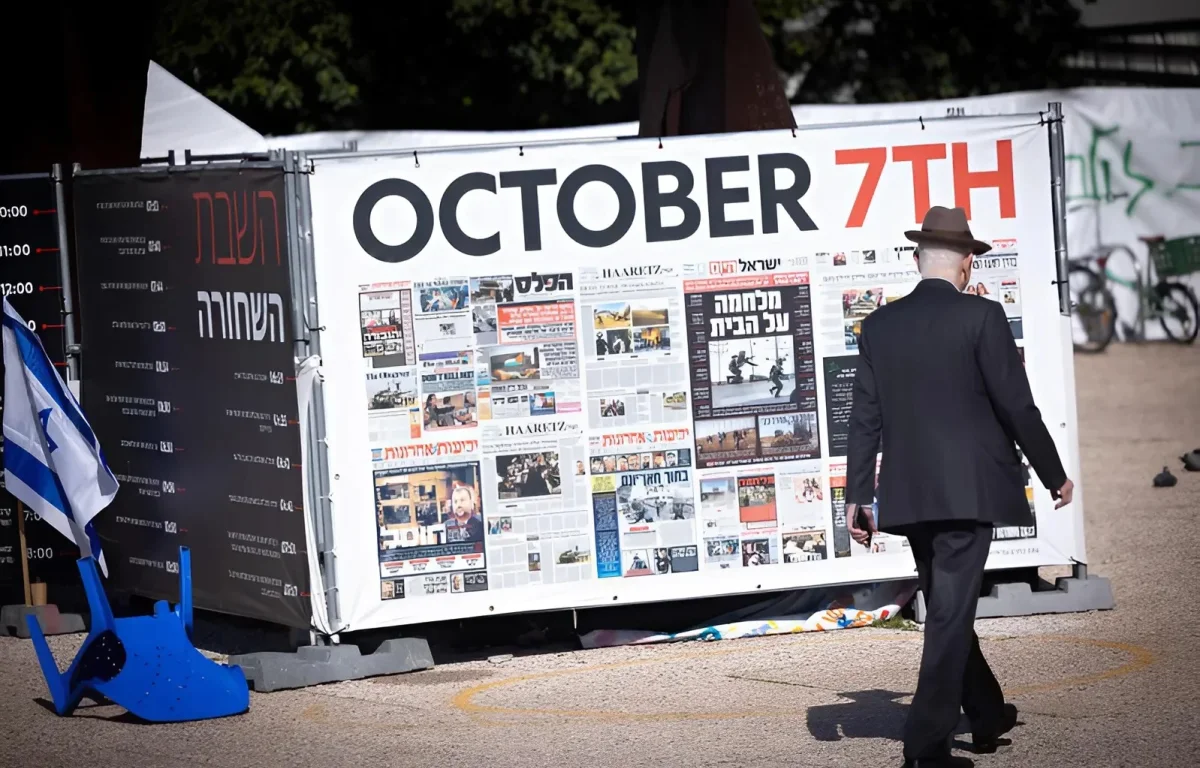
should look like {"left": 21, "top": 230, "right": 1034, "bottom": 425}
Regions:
{"left": 26, "top": 547, "right": 250, "bottom": 722}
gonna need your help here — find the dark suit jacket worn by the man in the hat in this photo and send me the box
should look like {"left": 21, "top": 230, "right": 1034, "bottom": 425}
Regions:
{"left": 846, "top": 278, "right": 1067, "bottom": 530}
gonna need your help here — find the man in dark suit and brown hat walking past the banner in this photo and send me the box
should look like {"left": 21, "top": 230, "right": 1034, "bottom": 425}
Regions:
{"left": 846, "top": 206, "right": 1074, "bottom": 767}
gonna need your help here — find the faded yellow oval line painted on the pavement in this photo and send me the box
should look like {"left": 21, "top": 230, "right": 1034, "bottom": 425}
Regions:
{"left": 450, "top": 634, "right": 1156, "bottom": 722}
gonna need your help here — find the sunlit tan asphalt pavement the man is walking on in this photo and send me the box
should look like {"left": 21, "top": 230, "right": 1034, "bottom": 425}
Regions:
{"left": 0, "top": 344, "right": 1200, "bottom": 768}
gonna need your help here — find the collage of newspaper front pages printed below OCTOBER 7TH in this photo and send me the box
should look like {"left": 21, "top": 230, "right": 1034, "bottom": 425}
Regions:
{"left": 359, "top": 240, "right": 1036, "bottom": 600}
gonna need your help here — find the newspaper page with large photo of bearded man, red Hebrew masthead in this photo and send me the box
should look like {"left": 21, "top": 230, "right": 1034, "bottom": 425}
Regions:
{"left": 372, "top": 439, "right": 487, "bottom": 600}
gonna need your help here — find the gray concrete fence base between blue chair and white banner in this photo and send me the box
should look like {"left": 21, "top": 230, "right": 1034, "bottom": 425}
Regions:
{"left": 229, "top": 637, "right": 433, "bottom": 692}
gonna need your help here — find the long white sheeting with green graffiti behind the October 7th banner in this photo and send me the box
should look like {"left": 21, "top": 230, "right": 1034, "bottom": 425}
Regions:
{"left": 266, "top": 88, "right": 1200, "bottom": 338}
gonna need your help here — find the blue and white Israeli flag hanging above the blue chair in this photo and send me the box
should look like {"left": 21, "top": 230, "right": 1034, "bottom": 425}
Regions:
{"left": 4, "top": 298, "right": 119, "bottom": 576}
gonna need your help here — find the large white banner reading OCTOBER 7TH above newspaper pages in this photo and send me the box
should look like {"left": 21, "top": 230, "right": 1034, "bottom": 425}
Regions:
{"left": 304, "top": 116, "right": 1085, "bottom": 630}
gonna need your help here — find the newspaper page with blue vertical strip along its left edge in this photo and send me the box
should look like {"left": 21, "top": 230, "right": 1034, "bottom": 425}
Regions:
{"left": 588, "top": 427, "right": 700, "bottom": 578}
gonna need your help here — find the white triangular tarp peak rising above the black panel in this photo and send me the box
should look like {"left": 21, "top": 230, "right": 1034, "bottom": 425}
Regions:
{"left": 142, "top": 61, "right": 268, "bottom": 163}
